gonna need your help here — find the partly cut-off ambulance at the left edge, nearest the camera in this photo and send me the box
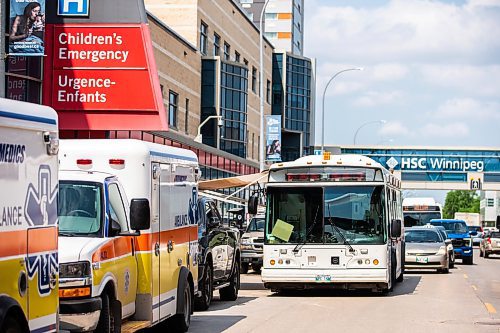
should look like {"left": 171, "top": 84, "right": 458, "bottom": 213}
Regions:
{"left": 0, "top": 98, "right": 58, "bottom": 333}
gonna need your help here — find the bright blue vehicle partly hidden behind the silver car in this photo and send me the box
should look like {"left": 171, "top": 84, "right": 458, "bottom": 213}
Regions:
{"left": 430, "top": 219, "right": 475, "bottom": 265}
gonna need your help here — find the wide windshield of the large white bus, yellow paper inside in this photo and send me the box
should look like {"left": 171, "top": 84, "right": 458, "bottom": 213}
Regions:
{"left": 265, "top": 186, "right": 386, "bottom": 245}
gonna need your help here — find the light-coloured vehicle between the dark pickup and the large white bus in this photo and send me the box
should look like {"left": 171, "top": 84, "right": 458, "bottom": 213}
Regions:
{"left": 240, "top": 215, "right": 266, "bottom": 274}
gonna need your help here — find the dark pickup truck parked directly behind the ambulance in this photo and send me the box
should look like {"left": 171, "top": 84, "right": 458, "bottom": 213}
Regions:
{"left": 195, "top": 197, "right": 240, "bottom": 310}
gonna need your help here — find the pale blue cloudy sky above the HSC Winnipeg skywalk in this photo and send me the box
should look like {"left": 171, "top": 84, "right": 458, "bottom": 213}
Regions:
{"left": 304, "top": 0, "right": 500, "bottom": 147}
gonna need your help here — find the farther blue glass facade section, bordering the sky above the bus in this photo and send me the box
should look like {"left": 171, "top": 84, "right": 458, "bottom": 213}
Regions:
{"left": 271, "top": 53, "right": 312, "bottom": 161}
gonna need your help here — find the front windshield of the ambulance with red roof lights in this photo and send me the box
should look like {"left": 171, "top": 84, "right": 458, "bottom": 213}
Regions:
{"left": 58, "top": 181, "right": 102, "bottom": 236}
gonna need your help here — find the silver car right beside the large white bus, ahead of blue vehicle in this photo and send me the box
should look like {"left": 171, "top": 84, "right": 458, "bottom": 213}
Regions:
{"left": 405, "top": 226, "right": 449, "bottom": 273}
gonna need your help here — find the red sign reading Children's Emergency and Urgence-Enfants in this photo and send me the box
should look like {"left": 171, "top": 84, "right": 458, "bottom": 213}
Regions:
{"left": 43, "top": 0, "right": 167, "bottom": 130}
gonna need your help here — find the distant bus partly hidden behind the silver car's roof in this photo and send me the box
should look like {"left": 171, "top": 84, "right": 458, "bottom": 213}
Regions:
{"left": 403, "top": 198, "right": 443, "bottom": 227}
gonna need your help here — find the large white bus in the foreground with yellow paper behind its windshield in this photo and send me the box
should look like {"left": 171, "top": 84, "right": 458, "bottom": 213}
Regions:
{"left": 254, "top": 155, "right": 404, "bottom": 292}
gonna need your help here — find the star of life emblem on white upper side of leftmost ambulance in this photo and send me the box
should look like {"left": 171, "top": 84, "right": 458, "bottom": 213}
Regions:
{"left": 24, "top": 165, "right": 57, "bottom": 226}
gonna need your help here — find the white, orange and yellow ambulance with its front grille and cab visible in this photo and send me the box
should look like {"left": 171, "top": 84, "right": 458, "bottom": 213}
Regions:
{"left": 59, "top": 139, "right": 200, "bottom": 332}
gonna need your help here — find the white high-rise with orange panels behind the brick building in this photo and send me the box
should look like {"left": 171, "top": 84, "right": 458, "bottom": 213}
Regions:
{"left": 239, "top": 0, "right": 304, "bottom": 55}
